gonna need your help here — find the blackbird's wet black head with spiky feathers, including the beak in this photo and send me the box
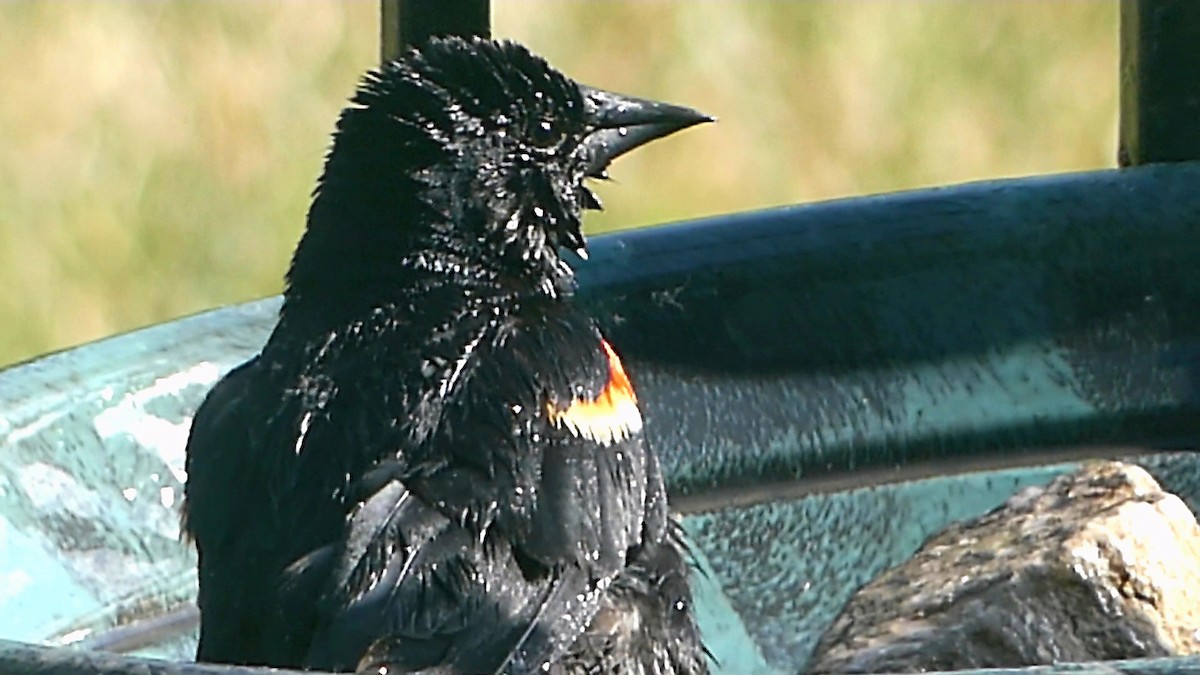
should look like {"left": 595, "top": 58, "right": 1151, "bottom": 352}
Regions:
{"left": 288, "top": 38, "right": 709, "bottom": 305}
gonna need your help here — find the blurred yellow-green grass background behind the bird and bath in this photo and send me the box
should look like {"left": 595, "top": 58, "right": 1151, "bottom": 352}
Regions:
{"left": 0, "top": 0, "right": 1117, "bottom": 364}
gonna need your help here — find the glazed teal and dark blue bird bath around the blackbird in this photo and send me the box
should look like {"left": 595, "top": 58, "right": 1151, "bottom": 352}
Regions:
{"left": 0, "top": 163, "right": 1200, "bottom": 673}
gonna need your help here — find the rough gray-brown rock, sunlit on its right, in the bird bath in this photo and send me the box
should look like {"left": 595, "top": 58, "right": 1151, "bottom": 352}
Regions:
{"left": 810, "top": 462, "right": 1200, "bottom": 673}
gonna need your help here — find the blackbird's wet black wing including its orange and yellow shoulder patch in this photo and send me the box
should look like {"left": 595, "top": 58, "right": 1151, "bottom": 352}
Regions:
{"left": 249, "top": 309, "right": 659, "bottom": 675}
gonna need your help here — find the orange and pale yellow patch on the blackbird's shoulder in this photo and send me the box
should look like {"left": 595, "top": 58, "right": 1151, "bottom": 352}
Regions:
{"left": 546, "top": 340, "right": 642, "bottom": 446}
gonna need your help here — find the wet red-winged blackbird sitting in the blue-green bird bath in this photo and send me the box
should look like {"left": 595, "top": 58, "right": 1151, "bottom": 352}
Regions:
{"left": 185, "top": 38, "right": 708, "bottom": 675}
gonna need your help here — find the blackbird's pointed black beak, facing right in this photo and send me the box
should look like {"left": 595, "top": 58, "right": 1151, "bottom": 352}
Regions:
{"left": 580, "top": 85, "right": 713, "bottom": 178}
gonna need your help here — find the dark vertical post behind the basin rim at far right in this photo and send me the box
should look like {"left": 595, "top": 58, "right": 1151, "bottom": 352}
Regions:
{"left": 1117, "top": 0, "right": 1200, "bottom": 166}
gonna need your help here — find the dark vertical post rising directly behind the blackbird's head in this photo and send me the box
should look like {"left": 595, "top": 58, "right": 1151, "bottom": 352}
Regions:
{"left": 379, "top": 0, "right": 492, "bottom": 61}
